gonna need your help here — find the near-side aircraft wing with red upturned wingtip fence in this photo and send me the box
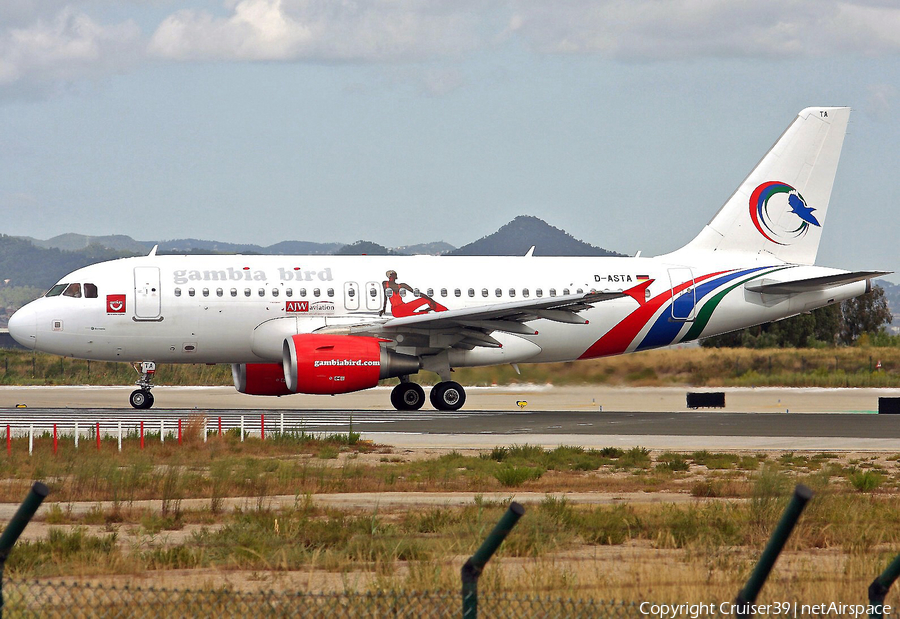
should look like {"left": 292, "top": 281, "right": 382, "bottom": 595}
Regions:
{"left": 340, "top": 280, "right": 653, "bottom": 349}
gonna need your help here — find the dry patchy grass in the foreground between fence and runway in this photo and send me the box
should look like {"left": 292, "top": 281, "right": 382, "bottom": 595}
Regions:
{"left": 0, "top": 435, "right": 900, "bottom": 602}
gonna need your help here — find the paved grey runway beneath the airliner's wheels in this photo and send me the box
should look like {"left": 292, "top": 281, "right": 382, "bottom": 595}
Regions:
{"left": 0, "top": 387, "right": 900, "bottom": 452}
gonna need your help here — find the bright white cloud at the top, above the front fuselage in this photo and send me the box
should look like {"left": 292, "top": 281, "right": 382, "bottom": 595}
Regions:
{"left": 150, "top": 0, "right": 479, "bottom": 62}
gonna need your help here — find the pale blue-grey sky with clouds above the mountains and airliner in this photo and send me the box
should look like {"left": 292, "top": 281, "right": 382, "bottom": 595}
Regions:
{"left": 0, "top": 0, "right": 900, "bottom": 281}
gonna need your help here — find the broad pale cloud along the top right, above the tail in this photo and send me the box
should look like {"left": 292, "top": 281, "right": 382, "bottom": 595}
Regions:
{"left": 508, "top": 0, "right": 900, "bottom": 60}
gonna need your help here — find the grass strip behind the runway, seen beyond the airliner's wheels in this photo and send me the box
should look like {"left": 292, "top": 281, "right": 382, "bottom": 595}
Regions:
{"left": 8, "top": 346, "right": 900, "bottom": 387}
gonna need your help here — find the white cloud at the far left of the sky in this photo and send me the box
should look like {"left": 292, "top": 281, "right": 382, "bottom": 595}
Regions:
{"left": 0, "top": 8, "right": 142, "bottom": 95}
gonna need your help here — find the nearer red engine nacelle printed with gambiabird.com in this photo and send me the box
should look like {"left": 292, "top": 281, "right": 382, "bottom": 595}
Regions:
{"left": 283, "top": 333, "right": 419, "bottom": 395}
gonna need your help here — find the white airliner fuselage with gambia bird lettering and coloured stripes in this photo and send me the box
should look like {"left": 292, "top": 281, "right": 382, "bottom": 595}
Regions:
{"left": 10, "top": 255, "right": 868, "bottom": 367}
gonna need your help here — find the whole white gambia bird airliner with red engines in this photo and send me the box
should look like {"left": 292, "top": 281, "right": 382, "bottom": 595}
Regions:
{"left": 9, "top": 107, "right": 885, "bottom": 410}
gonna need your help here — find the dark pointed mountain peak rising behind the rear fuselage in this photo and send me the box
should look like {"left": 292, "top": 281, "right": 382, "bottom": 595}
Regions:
{"left": 447, "top": 215, "right": 624, "bottom": 256}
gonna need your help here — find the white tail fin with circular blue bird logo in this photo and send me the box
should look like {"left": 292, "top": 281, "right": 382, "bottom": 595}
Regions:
{"left": 682, "top": 107, "right": 850, "bottom": 264}
